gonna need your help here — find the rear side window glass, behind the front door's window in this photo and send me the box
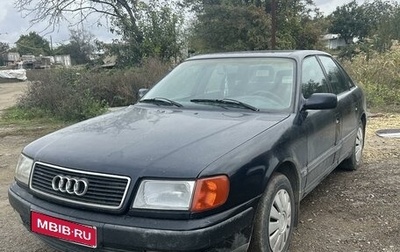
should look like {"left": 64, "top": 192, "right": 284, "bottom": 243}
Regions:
{"left": 319, "top": 56, "right": 350, "bottom": 94}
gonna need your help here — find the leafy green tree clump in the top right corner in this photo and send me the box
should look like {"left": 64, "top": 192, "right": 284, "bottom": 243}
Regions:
{"left": 328, "top": 0, "right": 400, "bottom": 60}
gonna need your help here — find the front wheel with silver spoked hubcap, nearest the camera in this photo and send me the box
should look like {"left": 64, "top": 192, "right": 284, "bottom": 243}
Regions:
{"left": 248, "top": 173, "right": 296, "bottom": 252}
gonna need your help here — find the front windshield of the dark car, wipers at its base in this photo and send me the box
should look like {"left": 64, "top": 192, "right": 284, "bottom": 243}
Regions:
{"left": 141, "top": 58, "right": 295, "bottom": 111}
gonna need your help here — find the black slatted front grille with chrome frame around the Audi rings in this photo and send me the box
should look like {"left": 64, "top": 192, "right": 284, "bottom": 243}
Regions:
{"left": 30, "top": 162, "right": 130, "bottom": 210}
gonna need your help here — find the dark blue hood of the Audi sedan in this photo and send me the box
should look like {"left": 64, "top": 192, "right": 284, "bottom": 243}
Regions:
{"left": 23, "top": 106, "right": 288, "bottom": 178}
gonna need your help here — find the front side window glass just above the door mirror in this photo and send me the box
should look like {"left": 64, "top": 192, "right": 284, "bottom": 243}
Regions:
{"left": 301, "top": 56, "right": 329, "bottom": 99}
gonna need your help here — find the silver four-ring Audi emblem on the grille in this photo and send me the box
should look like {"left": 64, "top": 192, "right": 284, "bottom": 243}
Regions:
{"left": 51, "top": 175, "right": 89, "bottom": 196}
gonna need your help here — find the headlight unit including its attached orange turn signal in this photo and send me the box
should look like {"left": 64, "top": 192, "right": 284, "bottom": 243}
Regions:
{"left": 132, "top": 175, "right": 230, "bottom": 212}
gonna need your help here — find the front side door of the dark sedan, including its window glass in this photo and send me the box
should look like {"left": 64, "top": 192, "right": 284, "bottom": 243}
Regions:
{"left": 302, "top": 57, "right": 341, "bottom": 193}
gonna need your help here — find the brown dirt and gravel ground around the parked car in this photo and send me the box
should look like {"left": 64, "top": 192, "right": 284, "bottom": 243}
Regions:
{"left": 0, "top": 83, "right": 400, "bottom": 252}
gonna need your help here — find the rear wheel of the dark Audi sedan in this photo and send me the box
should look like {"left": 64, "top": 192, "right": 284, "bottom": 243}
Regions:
{"left": 340, "top": 120, "right": 365, "bottom": 171}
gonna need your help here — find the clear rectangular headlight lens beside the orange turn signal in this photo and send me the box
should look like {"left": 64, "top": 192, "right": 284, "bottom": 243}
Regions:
{"left": 133, "top": 180, "right": 195, "bottom": 210}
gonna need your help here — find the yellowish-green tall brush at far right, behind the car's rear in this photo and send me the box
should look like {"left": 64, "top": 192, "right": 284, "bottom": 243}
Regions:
{"left": 343, "top": 50, "right": 400, "bottom": 111}
